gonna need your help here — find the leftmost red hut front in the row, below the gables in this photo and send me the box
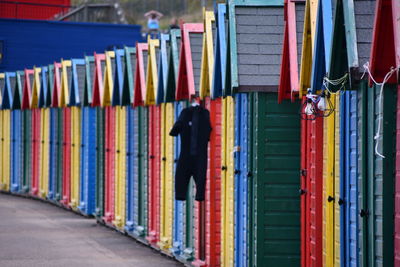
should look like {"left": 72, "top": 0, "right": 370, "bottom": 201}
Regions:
{"left": 31, "top": 108, "right": 41, "bottom": 196}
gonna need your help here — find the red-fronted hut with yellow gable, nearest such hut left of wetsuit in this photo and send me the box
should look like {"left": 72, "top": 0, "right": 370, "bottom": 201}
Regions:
{"left": 144, "top": 38, "right": 161, "bottom": 246}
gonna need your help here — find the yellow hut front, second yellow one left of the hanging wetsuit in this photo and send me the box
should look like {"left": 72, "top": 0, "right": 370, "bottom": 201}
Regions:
{"left": 113, "top": 106, "right": 126, "bottom": 230}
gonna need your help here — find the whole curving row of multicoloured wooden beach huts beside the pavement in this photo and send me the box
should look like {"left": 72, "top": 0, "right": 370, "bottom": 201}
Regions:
{"left": 0, "top": 0, "right": 400, "bottom": 267}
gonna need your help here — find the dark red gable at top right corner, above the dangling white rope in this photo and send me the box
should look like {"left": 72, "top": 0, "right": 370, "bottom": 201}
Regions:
{"left": 370, "top": 0, "right": 398, "bottom": 85}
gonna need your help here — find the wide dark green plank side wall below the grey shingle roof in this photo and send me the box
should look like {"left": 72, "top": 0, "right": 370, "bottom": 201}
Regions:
{"left": 250, "top": 93, "right": 300, "bottom": 266}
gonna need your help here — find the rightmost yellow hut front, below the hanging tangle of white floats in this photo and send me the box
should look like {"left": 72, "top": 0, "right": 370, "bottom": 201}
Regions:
{"left": 323, "top": 93, "right": 338, "bottom": 267}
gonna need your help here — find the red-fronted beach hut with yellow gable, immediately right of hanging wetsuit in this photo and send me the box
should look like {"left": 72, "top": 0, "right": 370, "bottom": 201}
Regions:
{"left": 192, "top": 8, "right": 220, "bottom": 266}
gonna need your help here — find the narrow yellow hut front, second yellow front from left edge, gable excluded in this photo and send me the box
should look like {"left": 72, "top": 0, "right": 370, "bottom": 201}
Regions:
{"left": 39, "top": 108, "right": 50, "bottom": 198}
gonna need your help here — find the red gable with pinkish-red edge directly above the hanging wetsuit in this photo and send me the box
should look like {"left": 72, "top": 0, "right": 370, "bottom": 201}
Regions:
{"left": 175, "top": 23, "right": 204, "bottom": 100}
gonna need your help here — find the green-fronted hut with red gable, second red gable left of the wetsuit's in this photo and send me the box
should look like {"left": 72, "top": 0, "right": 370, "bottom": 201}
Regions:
{"left": 92, "top": 53, "right": 106, "bottom": 219}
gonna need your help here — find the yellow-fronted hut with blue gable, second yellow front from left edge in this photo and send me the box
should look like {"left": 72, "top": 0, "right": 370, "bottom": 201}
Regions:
{"left": 38, "top": 66, "right": 50, "bottom": 199}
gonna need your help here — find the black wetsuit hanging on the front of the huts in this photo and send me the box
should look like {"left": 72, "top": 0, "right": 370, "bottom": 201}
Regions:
{"left": 169, "top": 106, "right": 211, "bottom": 201}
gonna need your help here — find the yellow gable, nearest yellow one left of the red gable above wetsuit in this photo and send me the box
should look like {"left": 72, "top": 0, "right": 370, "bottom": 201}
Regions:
{"left": 144, "top": 36, "right": 160, "bottom": 105}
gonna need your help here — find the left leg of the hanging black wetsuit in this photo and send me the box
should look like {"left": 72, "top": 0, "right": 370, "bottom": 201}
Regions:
{"left": 175, "top": 157, "right": 193, "bottom": 200}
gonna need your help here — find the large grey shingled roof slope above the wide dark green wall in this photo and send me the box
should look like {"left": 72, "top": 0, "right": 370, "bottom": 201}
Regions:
{"left": 235, "top": 6, "right": 284, "bottom": 90}
